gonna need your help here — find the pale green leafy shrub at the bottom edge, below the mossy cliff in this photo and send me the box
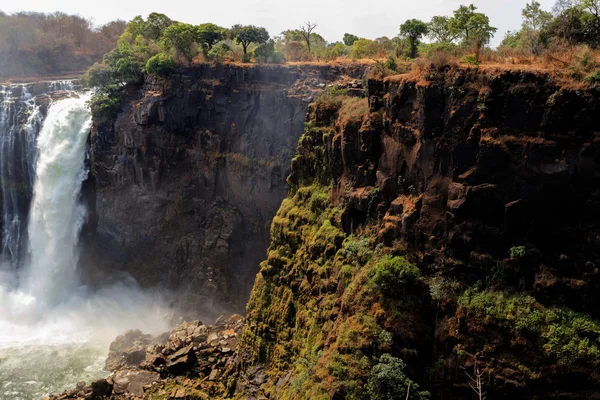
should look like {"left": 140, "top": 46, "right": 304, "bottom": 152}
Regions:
{"left": 367, "top": 354, "right": 429, "bottom": 400}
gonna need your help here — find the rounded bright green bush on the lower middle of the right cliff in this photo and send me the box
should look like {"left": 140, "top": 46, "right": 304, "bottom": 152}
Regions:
{"left": 369, "top": 256, "right": 421, "bottom": 298}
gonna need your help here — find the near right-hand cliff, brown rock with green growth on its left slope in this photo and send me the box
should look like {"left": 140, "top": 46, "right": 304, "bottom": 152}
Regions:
{"left": 240, "top": 69, "right": 600, "bottom": 399}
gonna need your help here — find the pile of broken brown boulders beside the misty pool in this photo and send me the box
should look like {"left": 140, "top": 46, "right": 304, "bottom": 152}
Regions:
{"left": 49, "top": 315, "right": 244, "bottom": 400}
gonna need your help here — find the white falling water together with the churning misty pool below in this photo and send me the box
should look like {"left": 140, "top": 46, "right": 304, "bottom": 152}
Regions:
{"left": 0, "top": 86, "right": 169, "bottom": 400}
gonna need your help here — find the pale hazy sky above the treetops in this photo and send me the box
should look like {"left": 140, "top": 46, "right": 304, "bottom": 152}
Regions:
{"left": 0, "top": 0, "right": 554, "bottom": 45}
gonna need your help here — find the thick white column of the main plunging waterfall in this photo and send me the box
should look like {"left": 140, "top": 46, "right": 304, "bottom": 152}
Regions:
{"left": 27, "top": 96, "right": 92, "bottom": 304}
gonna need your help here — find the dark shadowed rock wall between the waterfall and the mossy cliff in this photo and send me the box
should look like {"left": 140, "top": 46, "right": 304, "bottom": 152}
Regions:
{"left": 84, "top": 65, "right": 361, "bottom": 318}
